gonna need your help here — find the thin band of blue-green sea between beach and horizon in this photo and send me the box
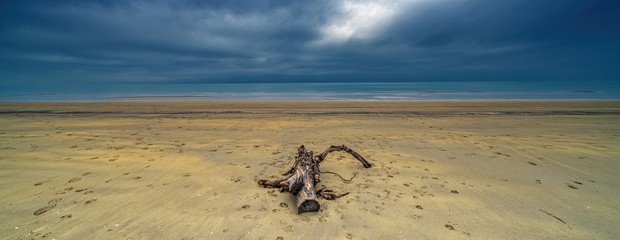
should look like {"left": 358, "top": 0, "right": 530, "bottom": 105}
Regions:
{"left": 0, "top": 81, "right": 620, "bottom": 101}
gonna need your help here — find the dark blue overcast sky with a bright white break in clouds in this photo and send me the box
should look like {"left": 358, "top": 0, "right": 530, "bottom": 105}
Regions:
{"left": 0, "top": 0, "right": 620, "bottom": 85}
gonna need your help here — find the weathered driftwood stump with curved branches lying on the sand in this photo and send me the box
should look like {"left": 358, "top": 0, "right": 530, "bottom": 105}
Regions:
{"left": 258, "top": 145, "right": 371, "bottom": 213}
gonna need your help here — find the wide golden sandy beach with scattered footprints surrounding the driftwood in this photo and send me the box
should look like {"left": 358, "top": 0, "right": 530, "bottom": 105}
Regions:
{"left": 0, "top": 101, "right": 620, "bottom": 239}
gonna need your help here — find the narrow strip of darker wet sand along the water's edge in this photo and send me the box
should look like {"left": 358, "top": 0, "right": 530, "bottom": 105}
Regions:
{"left": 0, "top": 101, "right": 620, "bottom": 116}
